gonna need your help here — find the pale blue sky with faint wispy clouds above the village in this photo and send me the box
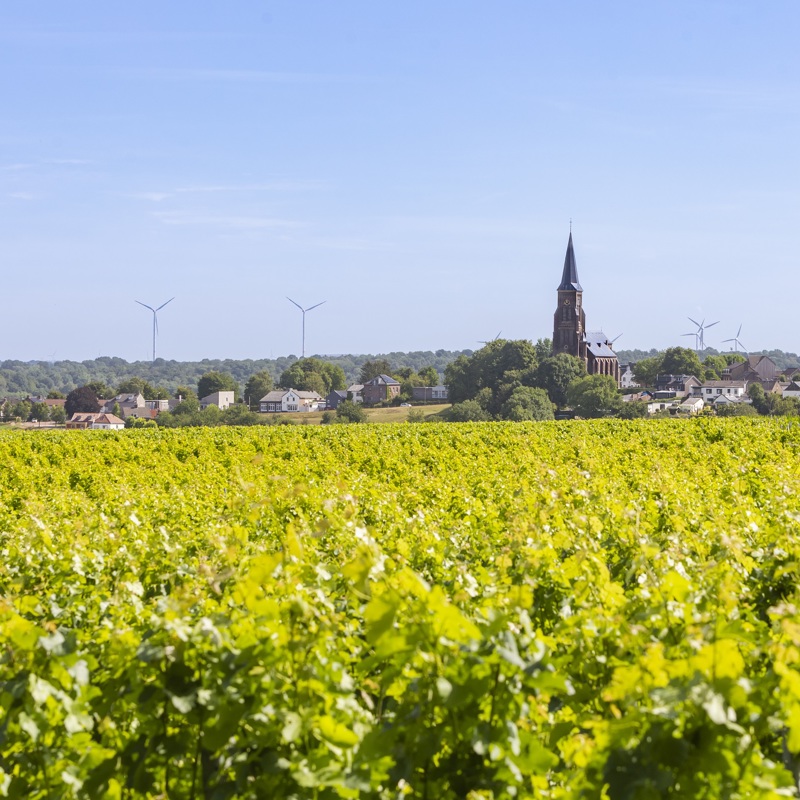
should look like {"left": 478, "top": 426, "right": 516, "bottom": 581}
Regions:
{"left": 0, "top": 0, "right": 800, "bottom": 361}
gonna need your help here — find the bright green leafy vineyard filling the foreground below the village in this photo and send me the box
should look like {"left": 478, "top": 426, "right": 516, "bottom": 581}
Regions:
{"left": 0, "top": 418, "right": 800, "bottom": 800}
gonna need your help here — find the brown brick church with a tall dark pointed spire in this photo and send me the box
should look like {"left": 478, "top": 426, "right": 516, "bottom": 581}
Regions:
{"left": 553, "top": 230, "right": 620, "bottom": 386}
